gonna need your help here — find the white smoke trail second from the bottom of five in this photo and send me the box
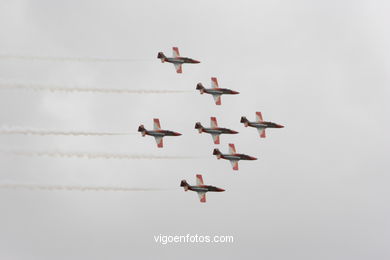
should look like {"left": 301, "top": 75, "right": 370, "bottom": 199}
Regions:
{"left": 4, "top": 151, "right": 195, "bottom": 160}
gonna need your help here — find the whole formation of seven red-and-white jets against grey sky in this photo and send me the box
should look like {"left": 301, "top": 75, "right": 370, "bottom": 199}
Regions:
{"left": 138, "top": 47, "right": 284, "bottom": 203}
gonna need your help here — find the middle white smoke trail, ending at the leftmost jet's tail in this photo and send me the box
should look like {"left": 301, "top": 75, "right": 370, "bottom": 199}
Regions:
{"left": 0, "top": 128, "right": 136, "bottom": 136}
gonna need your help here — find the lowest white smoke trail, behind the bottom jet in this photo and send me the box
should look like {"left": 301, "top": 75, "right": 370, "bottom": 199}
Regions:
{"left": 0, "top": 183, "right": 167, "bottom": 192}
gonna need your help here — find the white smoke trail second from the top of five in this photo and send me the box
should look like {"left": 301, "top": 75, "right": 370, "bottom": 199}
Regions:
{"left": 0, "top": 83, "right": 191, "bottom": 94}
